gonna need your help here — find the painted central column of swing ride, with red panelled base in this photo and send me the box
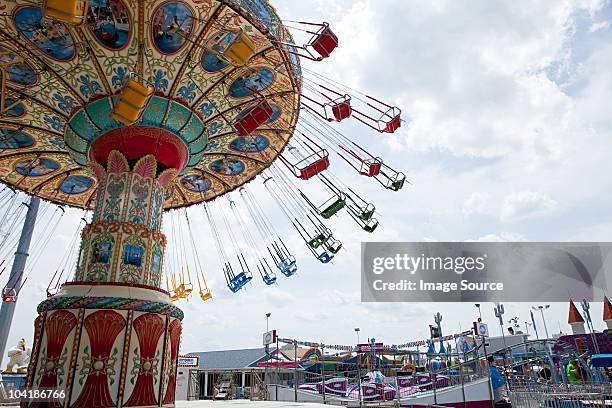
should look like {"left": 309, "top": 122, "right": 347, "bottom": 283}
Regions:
{"left": 23, "top": 139, "right": 186, "bottom": 408}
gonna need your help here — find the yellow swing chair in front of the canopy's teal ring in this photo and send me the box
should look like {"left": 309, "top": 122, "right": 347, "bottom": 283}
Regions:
{"left": 110, "top": 73, "right": 155, "bottom": 126}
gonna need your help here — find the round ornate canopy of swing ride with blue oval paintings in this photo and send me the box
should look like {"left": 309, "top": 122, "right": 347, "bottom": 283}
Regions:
{"left": 0, "top": 0, "right": 302, "bottom": 209}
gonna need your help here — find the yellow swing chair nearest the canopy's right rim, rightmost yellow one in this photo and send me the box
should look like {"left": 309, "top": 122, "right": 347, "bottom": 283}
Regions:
{"left": 207, "top": 27, "right": 255, "bottom": 67}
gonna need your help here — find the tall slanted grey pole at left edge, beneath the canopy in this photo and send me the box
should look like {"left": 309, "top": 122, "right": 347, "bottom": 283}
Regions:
{"left": 0, "top": 197, "right": 40, "bottom": 361}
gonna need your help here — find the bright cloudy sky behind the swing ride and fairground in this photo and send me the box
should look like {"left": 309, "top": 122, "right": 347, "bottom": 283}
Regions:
{"left": 0, "top": 0, "right": 612, "bottom": 364}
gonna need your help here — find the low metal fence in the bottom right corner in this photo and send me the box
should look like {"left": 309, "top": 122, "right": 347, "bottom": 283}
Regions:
{"left": 509, "top": 384, "right": 612, "bottom": 408}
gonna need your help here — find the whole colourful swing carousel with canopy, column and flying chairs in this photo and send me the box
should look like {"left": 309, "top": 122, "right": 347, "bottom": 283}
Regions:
{"left": 0, "top": 0, "right": 406, "bottom": 407}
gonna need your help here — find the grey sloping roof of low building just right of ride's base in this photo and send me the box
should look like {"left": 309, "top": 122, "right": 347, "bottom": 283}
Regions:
{"left": 188, "top": 347, "right": 276, "bottom": 370}
